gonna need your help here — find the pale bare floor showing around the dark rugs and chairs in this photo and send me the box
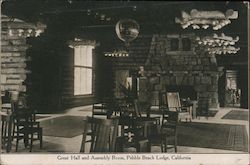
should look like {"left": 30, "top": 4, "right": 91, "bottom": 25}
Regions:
{"left": 3, "top": 106, "right": 249, "bottom": 153}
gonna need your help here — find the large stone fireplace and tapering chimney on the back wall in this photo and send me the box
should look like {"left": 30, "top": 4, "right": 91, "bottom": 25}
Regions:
{"left": 145, "top": 34, "right": 220, "bottom": 113}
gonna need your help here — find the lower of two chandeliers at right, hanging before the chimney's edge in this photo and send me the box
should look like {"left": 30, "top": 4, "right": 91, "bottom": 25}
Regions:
{"left": 196, "top": 33, "right": 240, "bottom": 54}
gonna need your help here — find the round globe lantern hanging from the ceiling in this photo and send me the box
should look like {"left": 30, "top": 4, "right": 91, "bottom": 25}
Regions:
{"left": 115, "top": 19, "right": 140, "bottom": 45}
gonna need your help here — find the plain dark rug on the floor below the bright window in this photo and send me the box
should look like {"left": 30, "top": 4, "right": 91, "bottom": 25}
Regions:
{"left": 41, "top": 116, "right": 85, "bottom": 138}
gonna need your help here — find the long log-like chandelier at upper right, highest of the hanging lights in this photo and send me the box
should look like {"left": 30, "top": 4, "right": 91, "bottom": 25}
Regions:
{"left": 175, "top": 9, "right": 238, "bottom": 30}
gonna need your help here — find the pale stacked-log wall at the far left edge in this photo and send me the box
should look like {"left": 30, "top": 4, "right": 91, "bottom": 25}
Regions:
{"left": 1, "top": 15, "right": 40, "bottom": 96}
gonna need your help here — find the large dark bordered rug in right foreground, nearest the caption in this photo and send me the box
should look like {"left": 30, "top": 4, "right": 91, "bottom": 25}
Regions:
{"left": 177, "top": 122, "right": 248, "bottom": 152}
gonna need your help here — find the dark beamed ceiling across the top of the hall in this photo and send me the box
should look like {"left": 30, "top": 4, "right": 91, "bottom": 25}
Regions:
{"left": 2, "top": 0, "right": 248, "bottom": 64}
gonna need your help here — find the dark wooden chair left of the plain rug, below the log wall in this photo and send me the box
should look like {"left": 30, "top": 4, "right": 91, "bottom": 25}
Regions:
{"left": 13, "top": 103, "right": 43, "bottom": 152}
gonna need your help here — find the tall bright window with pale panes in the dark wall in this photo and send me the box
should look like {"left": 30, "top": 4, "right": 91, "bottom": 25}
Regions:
{"left": 74, "top": 45, "right": 94, "bottom": 95}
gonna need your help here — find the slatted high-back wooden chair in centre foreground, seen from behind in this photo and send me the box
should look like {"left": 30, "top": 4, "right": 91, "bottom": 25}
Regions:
{"left": 80, "top": 117, "right": 118, "bottom": 152}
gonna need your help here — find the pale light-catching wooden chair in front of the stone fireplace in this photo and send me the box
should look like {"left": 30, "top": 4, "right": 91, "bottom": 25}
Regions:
{"left": 166, "top": 92, "right": 192, "bottom": 122}
